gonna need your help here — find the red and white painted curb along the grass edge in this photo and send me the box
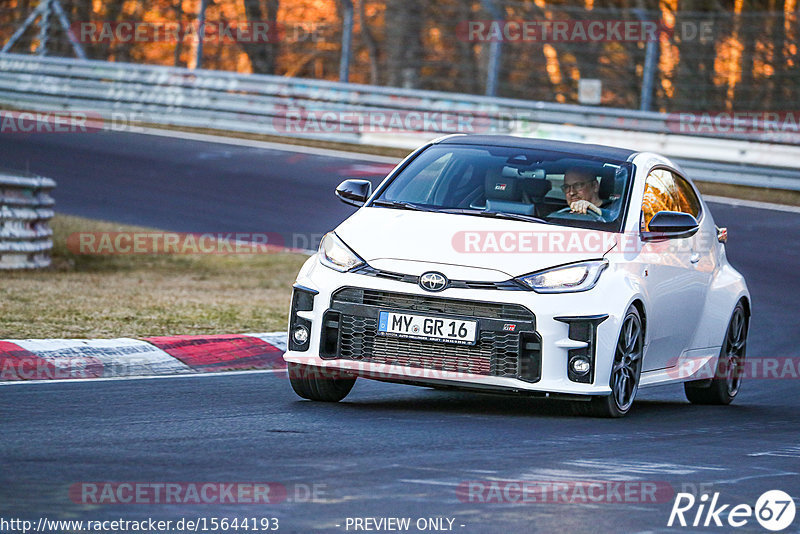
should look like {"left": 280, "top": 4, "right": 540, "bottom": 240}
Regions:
{"left": 0, "top": 332, "right": 286, "bottom": 383}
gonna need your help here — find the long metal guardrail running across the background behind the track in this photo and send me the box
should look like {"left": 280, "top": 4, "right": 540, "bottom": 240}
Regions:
{"left": 0, "top": 54, "right": 800, "bottom": 190}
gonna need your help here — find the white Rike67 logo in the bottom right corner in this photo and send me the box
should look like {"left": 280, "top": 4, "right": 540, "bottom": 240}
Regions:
{"left": 667, "top": 490, "right": 796, "bottom": 532}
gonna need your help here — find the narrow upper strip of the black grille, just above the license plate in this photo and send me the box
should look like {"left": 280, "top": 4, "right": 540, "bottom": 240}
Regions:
{"left": 333, "top": 287, "right": 534, "bottom": 322}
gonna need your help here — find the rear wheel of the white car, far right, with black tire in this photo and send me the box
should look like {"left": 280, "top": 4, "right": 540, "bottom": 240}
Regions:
{"left": 683, "top": 301, "right": 749, "bottom": 405}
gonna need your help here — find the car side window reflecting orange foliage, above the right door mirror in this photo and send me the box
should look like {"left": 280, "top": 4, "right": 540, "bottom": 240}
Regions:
{"left": 641, "top": 169, "right": 700, "bottom": 231}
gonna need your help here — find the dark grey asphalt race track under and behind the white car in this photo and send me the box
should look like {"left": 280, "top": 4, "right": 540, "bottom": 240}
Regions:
{"left": 0, "top": 133, "right": 800, "bottom": 533}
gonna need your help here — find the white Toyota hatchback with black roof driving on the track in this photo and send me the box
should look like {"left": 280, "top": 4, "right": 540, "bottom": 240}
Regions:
{"left": 284, "top": 135, "right": 750, "bottom": 417}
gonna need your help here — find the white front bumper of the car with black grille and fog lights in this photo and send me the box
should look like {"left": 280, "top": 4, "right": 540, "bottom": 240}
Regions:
{"left": 284, "top": 258, "right": 627, "bottom": 395}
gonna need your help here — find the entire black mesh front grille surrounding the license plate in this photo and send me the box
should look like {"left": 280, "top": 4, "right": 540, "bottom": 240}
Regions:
{"left": 331, "top": 288, "right": 541, "bottom": 382}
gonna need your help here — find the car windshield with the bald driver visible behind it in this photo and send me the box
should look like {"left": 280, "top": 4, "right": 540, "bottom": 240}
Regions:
{"left": 370, "top": 144, "right": 633, "bottom": 232}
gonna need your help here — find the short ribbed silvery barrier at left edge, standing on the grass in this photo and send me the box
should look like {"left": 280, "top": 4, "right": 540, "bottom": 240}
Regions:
{"left": 0, "top": 171, "right": 56, "bottom": 269}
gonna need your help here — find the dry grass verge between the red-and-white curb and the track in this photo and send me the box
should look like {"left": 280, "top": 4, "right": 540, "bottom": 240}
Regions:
{"left": 0, "top": 215, "right": 307, "bottom": 339}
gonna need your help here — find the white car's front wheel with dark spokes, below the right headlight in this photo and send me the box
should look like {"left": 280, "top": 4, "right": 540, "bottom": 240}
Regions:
{"left": 573, "top": 306, "right": 644, "bottom": 417}
